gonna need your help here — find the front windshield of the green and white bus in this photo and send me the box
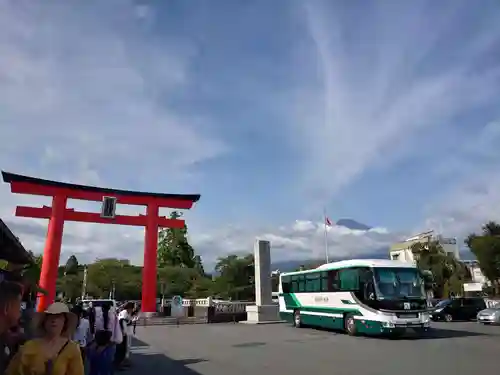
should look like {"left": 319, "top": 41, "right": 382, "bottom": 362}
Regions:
{"left": 373, "top": 267, "right": 425, "bottom": 299}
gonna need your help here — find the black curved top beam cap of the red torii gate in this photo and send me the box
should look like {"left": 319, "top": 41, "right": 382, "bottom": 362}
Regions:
{"left": 2, "top": 171, "right": 200, "bottom": 202}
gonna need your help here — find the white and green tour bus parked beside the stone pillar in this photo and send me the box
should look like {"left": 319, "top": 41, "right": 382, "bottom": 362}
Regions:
{"left": 279, "top": 259, "right": 430, "bottom": 336}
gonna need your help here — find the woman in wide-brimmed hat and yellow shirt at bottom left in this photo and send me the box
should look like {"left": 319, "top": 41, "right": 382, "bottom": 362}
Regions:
{"left": 6, "top": 302, "right": 84, "bottom": 375}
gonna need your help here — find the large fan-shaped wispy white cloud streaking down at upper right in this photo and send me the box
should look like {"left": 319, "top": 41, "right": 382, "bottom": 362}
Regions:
{"left": 289, "top": 2, "right": 500, "bottom": 209}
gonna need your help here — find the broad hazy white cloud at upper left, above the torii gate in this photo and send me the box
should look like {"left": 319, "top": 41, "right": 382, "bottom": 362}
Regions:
{"left": 0, "top": 0, "right": 226, "bottom": 187}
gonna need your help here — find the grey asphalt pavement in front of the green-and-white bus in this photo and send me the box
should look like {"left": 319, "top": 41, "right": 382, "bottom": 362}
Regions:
{"left": 128, "top": 322, "right": 500, "bottom": 375}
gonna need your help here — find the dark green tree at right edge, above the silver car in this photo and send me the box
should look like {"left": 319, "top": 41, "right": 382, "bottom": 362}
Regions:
{"left": 465, "top": 221, "right": 500, "bottom": 295}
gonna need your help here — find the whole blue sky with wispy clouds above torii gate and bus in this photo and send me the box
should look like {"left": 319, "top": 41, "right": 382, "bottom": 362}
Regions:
{"left": 0, "top": 0, "right": 500, "bottom": 263}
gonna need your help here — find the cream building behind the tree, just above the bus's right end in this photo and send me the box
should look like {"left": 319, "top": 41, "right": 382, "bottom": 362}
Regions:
{"left": 389, "top": 230, "right": 460, "bottom": 263}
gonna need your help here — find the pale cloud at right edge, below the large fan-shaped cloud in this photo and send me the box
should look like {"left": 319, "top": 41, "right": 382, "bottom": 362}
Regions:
{"left": 425, "top": 121, "right": 500, "bottom": 237}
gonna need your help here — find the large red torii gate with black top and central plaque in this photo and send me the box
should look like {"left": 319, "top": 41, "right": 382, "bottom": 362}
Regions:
{"left": 2, "top": 171, "right": 200, "bottom": 313}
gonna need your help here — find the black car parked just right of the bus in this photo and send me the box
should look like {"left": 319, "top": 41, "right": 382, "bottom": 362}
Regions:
{"left": 431, "top": 298, "right": 486, "bottom": 322}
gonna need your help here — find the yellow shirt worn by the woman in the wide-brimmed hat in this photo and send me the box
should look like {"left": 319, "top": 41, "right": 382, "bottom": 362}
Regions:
{"left": 6, "top": 339, "right": 84, "bottom": 375}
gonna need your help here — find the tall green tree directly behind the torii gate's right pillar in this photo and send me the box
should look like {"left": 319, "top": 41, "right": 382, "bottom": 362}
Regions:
{"left": 158, "top": 211, "right": 201, "bottom": 268}
